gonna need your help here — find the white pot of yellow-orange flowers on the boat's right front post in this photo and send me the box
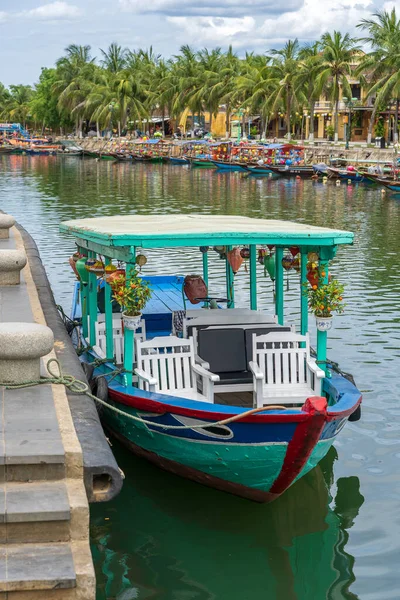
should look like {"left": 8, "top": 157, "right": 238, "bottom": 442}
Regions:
{"left": 306, "top": 273, "right": 344, "bottom": 331}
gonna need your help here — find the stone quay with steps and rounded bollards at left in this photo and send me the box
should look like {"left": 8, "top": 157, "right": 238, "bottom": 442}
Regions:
{"left": 0, "top": 215, "right": 122, "bottom": 600}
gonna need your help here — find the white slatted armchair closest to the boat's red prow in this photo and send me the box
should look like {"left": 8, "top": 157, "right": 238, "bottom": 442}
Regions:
{"left": 249, "top": 332, "right": 325, "bottom": 407}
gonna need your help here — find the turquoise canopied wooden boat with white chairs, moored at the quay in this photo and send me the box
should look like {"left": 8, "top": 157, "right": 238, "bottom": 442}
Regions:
{"left": 60, "top": 214, "right": 361, "bottom": 502}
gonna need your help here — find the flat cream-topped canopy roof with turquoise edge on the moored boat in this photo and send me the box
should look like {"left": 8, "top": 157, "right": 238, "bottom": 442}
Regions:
{"left": 60, "top": 214, "right": 354, "bottom": 251}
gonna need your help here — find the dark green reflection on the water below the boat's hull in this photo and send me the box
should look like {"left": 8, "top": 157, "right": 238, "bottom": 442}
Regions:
{"left": 92, "top": 440, "right": 364, "bottom": 600}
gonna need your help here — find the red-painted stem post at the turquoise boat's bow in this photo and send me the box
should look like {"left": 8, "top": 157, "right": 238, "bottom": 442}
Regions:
{"left": 270, "top": 396, "right": 327, "bottom": 495}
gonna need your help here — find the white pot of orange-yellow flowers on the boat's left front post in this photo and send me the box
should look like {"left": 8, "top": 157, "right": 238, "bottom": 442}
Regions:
{"left": 110, "top": 271, "right": 151, "bottom": 330}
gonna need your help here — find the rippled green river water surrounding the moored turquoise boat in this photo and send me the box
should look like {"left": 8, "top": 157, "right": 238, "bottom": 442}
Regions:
{"left": 0, "top": 156, "right": 400, "bottom": 600}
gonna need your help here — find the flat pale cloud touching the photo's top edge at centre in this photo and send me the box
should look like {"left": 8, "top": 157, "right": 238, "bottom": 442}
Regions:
{"left": 119, "top": 0, "right": 304, "bottom": 17}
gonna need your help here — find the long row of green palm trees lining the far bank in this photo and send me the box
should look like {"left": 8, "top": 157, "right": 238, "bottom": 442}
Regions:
{"left": 0, "top": 8, "right": 400, "bottom": 143}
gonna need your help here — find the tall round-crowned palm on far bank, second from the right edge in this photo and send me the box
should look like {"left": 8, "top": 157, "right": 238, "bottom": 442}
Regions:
{"left": 316, "top": 31, "right": 360, "bottom": 142}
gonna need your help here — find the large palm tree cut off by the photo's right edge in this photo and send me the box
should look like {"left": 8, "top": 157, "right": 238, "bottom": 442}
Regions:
{"left": 358, "top": 8, "right": 400, "bottom": 143}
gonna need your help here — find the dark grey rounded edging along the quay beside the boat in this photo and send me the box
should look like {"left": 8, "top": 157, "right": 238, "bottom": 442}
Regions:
{"left": 15, "top": 223, "right": 123, "bottom": 503}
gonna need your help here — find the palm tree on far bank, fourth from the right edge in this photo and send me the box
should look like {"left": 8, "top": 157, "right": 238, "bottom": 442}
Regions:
{"left": 269, "top": 39, "right": 300, "bottom": 140}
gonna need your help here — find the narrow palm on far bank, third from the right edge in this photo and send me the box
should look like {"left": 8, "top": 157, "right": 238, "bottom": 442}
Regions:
{"left": 296, "top": 42, "right": 322, "bottom": 142}
